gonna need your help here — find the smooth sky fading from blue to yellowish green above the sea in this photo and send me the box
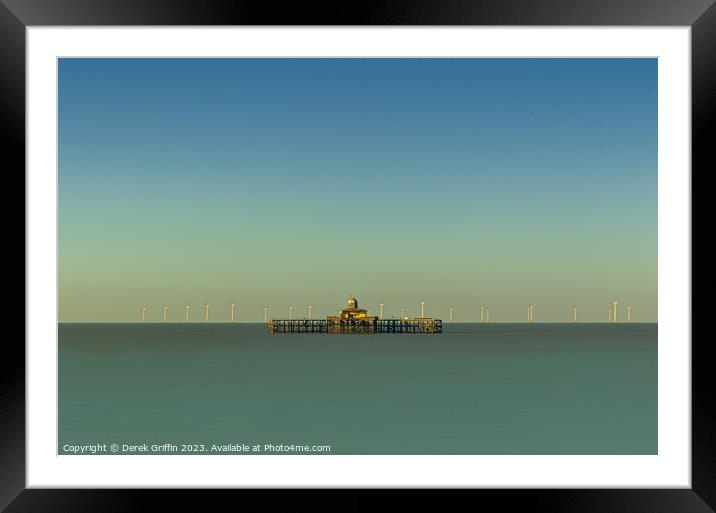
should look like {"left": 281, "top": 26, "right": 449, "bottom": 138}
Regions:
{"left": 58, "top": 58, "right": 658, "bottom": 323}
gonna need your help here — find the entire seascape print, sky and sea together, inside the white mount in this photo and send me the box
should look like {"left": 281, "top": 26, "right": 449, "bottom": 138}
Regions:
{"left": 57, "top": 58, "right": 656, "bottom": 455}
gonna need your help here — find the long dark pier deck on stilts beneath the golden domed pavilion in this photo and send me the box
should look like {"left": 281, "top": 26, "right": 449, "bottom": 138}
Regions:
{"left": 268, "top": 318, "right": 443, "bottom": 334}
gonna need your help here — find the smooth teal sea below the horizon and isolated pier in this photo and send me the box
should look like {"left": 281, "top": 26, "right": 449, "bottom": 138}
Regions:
{"left": 58, "top": 324, "right": 657, "bottom": 454}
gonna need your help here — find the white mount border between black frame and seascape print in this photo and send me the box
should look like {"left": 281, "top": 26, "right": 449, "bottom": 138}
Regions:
{"left": 26, "top": 27, "right": 691, "bottom": 488}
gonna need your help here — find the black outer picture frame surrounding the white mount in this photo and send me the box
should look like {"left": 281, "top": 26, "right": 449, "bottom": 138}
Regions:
{"left": 0, "top": 0, "right": 716, "bottom": 513}
